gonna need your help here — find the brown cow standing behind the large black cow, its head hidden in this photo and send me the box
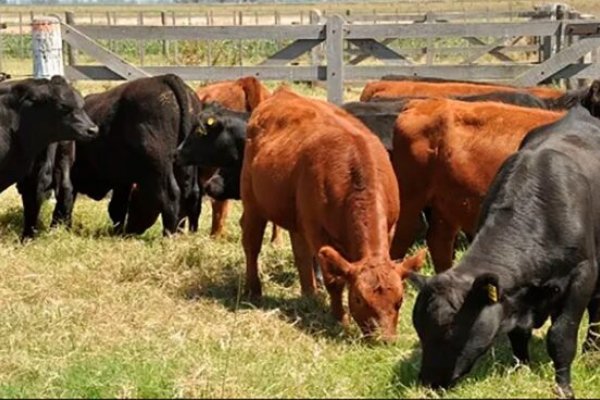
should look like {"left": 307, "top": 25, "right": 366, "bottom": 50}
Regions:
{"left": 392, "top": 98, "right": 564, "bottom": 272}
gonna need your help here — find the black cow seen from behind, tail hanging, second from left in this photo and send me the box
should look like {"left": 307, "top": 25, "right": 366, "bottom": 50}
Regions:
{"left": 72, "top": 74, "right": 200, "bottom": 234}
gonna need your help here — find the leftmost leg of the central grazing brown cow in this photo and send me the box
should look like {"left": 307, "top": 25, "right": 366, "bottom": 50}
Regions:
{"left": 241, "top": 206, "right": 267, "bottom": 299}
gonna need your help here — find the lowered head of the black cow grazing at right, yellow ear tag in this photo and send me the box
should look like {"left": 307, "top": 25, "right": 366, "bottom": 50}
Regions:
{"left": 410, "top": 270, "right": 503, "bottom": 388}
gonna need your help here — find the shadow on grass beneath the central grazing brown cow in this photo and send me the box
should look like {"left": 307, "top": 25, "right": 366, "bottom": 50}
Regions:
{"left": 181, "top": 270, "right": 344, "bottom": 338}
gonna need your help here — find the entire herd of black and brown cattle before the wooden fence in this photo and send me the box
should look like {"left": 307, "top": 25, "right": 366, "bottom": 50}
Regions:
{"left": 0, "top": 75, "right": 600, "bottom": 397}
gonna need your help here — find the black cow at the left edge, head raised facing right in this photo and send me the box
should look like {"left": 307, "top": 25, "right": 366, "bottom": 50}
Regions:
{"left": 0, "top": 76, "right": 98, "bottom": 237}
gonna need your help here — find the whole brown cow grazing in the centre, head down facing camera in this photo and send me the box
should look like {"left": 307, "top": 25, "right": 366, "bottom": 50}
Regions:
{"left": 241, "top": 88, "right": 425, "bottom": 340}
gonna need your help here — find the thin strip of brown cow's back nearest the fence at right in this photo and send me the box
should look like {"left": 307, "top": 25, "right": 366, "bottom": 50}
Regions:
{"left": 360, "top": 81, "right": 564, "bottom": 101}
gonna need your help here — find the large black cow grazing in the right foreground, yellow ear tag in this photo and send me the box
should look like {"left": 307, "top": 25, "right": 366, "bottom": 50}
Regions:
{"left": 413, "top": 107, "right": 600, "bottom": 397}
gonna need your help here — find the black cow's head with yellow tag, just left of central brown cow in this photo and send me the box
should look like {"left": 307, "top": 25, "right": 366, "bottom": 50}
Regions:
{"left": 176, "top": 103, "right": 248, "bottom": 167}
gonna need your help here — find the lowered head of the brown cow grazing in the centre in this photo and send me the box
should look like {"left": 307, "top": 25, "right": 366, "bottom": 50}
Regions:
{"left": 318, "top": 246, "right": 426, "bottom": 341}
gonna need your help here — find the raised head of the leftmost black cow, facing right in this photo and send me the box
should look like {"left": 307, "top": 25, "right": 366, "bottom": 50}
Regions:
{"left": 11, "top": 76, "right": 98, "bottom": 144}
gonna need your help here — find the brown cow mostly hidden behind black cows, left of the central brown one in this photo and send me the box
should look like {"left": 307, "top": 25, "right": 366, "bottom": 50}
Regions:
{"left": 196, "top": 76, "right": 281, "bottom": 243}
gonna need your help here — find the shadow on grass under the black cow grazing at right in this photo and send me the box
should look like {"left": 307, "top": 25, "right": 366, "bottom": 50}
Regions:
{"left": 391, "top": 336, "right": 550, "bottom": 398}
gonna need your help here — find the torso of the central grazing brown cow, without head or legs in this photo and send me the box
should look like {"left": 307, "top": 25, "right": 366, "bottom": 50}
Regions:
{"left": 242, "top": 89, "right": 399, "bottom": 248}
